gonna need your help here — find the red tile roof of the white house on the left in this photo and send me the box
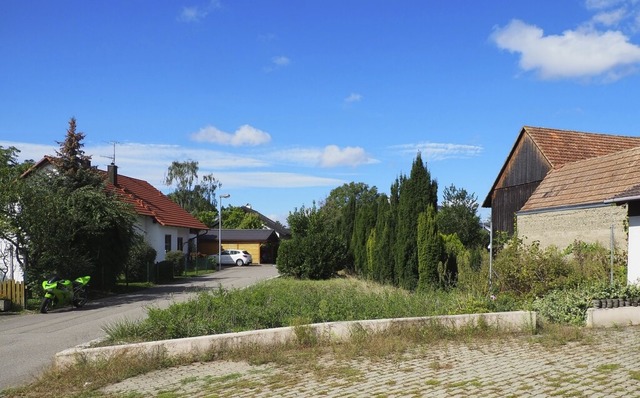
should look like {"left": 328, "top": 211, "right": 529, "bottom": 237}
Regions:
{"left": 99, "top": 170, "right": 209, "bottom": 230}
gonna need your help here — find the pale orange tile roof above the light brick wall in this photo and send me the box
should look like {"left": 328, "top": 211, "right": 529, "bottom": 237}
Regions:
{"left": 521, "top": 147, "right": 640, "bottom": 211}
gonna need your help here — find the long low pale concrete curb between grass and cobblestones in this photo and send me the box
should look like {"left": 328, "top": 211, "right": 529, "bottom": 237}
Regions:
{"left": 55, "top": 311, "right": 537, "bottom": 366}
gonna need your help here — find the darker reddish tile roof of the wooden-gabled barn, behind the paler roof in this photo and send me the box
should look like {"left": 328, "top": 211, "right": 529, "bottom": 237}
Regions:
{"left": 523, "top": 126, "right": 640, "bottom": 168}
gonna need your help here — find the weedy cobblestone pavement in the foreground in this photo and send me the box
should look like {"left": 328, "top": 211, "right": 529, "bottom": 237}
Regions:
{"left": 103, "top": 327, "right": 640, "bottom": 398}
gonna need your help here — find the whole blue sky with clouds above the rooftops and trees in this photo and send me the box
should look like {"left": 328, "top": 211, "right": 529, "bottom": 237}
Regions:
{"left": 0, "top": 0, "right": 640, "bottom": 222}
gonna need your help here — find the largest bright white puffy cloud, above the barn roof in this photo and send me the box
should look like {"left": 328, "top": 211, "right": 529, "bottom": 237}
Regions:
{"left": 491, "top": 20, "right": 640, "bottom": 80}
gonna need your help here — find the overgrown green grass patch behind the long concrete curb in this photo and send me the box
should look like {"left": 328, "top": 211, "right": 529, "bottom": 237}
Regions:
{"left": 105, "top": 278, "right": 517, "bottom": 342}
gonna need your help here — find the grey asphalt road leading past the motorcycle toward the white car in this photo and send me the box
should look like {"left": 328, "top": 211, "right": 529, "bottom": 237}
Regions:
{"left": 0, "top": 265, "right": 278, "bottom": 391}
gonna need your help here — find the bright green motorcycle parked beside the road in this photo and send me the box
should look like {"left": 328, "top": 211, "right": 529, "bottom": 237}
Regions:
{"left": 40, "top": 275, "right": 91, "bottom": 314}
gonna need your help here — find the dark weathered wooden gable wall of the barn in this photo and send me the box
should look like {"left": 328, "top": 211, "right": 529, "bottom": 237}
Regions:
{"left": 491, "top": 133, "right": 551, "bottom": 234}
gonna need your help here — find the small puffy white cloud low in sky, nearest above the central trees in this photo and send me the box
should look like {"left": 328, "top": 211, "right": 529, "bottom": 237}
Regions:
{"left": 276, "top": 145, "right": 378, "bottom": 168}
